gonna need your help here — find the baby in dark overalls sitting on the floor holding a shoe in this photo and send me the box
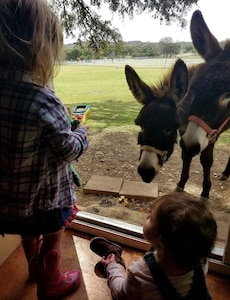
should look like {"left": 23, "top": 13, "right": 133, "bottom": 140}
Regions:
{"left": 90, "top": 193, "right": 217, "bottom": 300}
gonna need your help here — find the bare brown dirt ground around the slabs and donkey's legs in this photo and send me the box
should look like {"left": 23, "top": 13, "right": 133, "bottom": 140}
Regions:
{"left": 74, "top": 130, "right": 230, "bottom": 224}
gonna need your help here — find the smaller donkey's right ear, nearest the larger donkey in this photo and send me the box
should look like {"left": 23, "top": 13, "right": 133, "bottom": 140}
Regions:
{"left": 170, "top": 59, "right": 188, "bottom": 104}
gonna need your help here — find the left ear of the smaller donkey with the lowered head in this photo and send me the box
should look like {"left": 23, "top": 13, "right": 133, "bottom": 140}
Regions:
{"left": 125, "top": 65, "right": 154, "bottom": 105}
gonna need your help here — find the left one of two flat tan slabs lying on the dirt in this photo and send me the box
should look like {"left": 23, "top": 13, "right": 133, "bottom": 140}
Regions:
{"left": 83, "top": 175, "right": 123, "bottom": 196}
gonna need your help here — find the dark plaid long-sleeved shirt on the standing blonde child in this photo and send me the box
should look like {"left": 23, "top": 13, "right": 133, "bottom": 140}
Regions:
{"left": 0, "top": 68, "right": 88, "bottom": 220}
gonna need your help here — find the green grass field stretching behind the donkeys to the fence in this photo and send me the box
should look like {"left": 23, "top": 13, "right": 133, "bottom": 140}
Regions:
{"left": 54, "top": 65, "right": 165, "bottom": 131}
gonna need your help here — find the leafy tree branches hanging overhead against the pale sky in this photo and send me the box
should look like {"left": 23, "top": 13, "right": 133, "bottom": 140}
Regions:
{"left": 48, "top": 0, "right": 199, "bottom": 51}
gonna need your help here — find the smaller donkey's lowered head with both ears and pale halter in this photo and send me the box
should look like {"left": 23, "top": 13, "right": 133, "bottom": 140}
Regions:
{"left": 125, "top": 59, "right": 189, "bottom": 183}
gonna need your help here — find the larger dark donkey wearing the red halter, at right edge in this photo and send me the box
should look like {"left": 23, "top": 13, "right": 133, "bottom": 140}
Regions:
{"left": 177, "top": 10, "right": 230, "bottom": 200}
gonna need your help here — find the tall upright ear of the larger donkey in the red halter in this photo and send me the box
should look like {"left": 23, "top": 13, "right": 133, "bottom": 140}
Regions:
{"left": 190, "top": 10, "right": 222, "bottom": 61}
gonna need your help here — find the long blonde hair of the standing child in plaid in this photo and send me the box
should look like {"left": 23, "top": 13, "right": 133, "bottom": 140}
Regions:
{"left": 0, "top": 0, "right": 63, "bottom": 85}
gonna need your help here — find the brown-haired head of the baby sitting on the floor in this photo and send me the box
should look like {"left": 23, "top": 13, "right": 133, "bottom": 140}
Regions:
{"left": 143, "top": 193, "right": 217, "bottom": 268}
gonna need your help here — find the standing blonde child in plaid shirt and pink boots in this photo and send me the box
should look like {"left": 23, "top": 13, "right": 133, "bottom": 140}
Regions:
{"left": 0, "top": 0, "right": 88, "bottom": 300}
